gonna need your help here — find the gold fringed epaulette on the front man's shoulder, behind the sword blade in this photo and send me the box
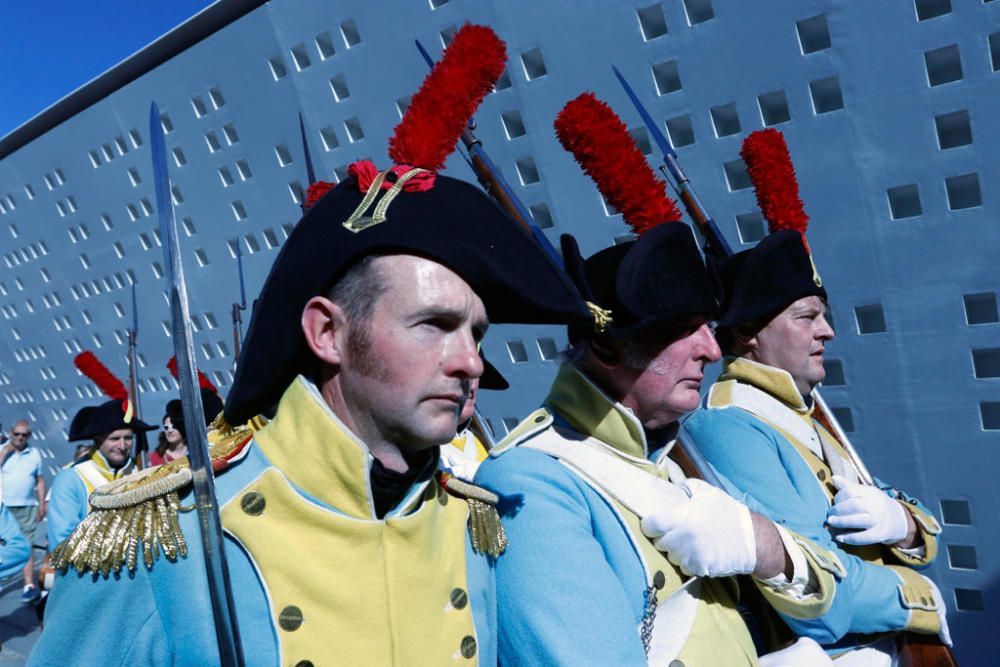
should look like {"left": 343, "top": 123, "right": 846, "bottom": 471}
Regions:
{"left": 52, "top": 415, "right": 266, "bottom": 577}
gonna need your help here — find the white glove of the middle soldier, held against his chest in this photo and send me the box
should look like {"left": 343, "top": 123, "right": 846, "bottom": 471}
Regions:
{"left": 640, "top": 479, "right": 757, "bottom": 577}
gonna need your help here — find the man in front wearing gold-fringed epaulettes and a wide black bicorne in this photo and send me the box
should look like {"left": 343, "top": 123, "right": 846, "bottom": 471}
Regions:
{"left": 32, "top": 26, "right": 582, "bottom": 666}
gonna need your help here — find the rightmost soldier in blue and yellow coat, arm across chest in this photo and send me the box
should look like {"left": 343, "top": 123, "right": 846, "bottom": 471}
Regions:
{"left": 682, "top": 130, "right": 951, "bottom": 665}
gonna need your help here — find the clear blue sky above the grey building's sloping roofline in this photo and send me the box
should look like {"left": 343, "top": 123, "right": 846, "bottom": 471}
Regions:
{"left": 0, "top": 0, "right": 212, "bottom": 136}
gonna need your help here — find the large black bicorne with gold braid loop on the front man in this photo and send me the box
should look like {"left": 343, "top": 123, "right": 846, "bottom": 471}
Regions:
{"left": 225, "top": 174, "right": 587, "bottom": 424}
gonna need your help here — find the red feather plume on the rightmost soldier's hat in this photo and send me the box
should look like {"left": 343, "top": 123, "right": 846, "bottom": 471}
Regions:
{"left": 740, "top": 128, "right": 809, "bottom": 239}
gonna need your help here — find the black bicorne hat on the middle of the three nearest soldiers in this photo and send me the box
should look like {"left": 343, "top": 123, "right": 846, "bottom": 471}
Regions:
{"left": 562, "top": 222, "right": 718, "bottom": 341}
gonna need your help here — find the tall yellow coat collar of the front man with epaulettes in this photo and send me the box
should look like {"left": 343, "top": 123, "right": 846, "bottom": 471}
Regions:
{"left": 254, "top": 375, "right": 429, "bottom": 520}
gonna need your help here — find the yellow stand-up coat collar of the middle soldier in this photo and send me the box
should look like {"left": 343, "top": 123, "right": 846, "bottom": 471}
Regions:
{"left": 545, "top": 363, "right": 649, "bottom": 459}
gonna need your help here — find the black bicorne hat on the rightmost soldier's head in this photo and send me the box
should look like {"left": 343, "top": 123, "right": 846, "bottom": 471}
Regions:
{"left": 719, "top": 229, "right": 827, "bottom": 327}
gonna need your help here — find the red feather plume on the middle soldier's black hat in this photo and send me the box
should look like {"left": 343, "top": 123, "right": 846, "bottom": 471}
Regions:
{"left": 555, "top": 93, "right": 681, "bottom": 234}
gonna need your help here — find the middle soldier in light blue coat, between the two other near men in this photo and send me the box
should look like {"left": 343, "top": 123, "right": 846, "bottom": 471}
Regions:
{"left": 476, "top": 94, "right": 842, "bottom": 665}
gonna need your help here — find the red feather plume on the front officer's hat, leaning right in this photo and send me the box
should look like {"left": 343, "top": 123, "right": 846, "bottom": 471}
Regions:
{"left": 389, "top": 24, "right": 507, "bottom": 171}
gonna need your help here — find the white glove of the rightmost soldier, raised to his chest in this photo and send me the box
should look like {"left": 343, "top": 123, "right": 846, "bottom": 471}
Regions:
{"left": 826, "top": 475, "right": 910, "bottom": 544}
